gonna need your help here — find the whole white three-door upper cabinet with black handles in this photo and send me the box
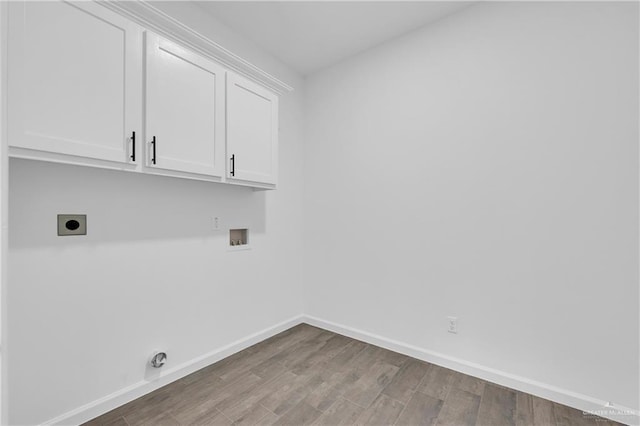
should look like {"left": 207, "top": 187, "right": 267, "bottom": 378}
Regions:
{"left": 5, "top": 0, "right": 284, "bottom": 189}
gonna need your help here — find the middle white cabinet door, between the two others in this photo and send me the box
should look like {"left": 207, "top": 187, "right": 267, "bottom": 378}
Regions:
{"left": 146, "top": 33, "right": 225, "bottom": 177}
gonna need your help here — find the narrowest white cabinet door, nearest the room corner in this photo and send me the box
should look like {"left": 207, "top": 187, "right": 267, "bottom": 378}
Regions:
{"left": 227, "top": 73, "right": 278, "bottom": 185}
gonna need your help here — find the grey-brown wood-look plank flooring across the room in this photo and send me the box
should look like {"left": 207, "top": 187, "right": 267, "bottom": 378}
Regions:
{"left": 86, "top": 324, "right": 616, "bottom": 426}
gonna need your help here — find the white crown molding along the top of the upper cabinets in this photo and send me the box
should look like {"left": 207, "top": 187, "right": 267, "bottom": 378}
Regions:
{"left": 99, "top": 0, "right": 293, "bottom": 94}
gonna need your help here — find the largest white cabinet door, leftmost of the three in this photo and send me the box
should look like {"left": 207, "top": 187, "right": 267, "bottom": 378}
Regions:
{"left": 8, "top": 1, "right": 142, "bottom": 163}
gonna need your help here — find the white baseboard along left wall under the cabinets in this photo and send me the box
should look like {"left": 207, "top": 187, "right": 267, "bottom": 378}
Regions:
{"left": 43, "top": 315, "right": 304, "bottom": 425}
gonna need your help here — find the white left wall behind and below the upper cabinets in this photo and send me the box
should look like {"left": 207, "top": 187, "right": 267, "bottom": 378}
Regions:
{"left": 3, "top": 3, "right": 302, "bottom": 425}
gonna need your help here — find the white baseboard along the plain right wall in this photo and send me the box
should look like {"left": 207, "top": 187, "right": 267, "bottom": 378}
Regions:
{"left": 302, "top": 315, "right": 640, "bottom": 425}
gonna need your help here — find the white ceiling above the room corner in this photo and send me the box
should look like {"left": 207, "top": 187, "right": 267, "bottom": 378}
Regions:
{"left": 195, "top": 1, "right": 470, "bottom": 75}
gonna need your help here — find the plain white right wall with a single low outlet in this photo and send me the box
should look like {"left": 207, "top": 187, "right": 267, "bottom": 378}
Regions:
{"left": 305, "top": 2, "right": 639, "bottom": 409}
